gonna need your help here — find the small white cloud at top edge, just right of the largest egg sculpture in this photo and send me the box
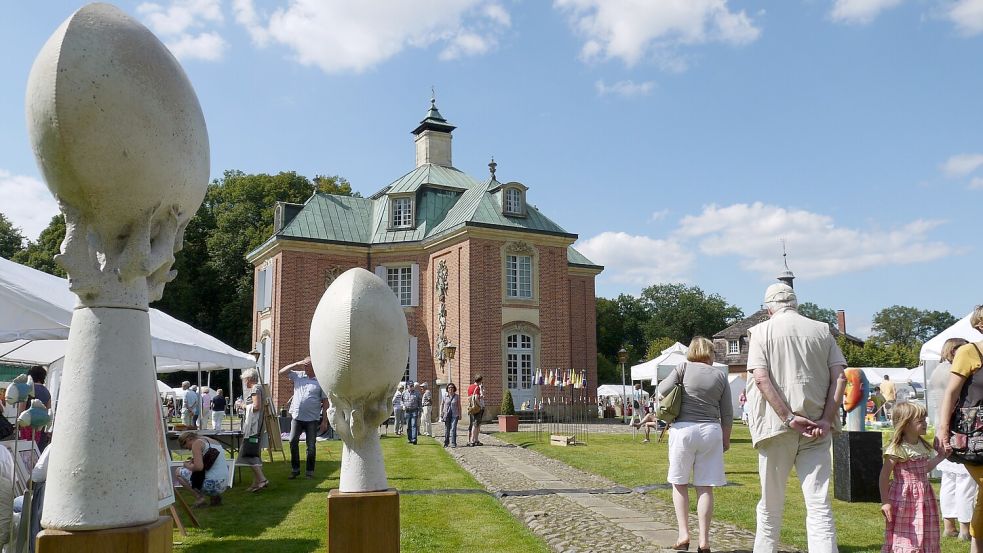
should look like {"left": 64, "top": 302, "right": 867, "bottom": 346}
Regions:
{"left": 137, "top": 0, "right": 228, "bottom": 61}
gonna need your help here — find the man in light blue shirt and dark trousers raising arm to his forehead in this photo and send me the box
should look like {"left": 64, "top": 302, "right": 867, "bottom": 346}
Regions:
{"left": 280, "top": 356, "right": 329, "bottom": 480}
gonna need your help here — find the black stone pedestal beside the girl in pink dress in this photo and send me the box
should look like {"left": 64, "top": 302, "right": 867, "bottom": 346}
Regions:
{"left": 833, "top": 432, "right": 883, "bottom": 503}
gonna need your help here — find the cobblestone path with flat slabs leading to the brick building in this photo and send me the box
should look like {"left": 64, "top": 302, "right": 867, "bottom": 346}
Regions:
{"left": 435, "top": 425, "right": 795, "bottom": 553}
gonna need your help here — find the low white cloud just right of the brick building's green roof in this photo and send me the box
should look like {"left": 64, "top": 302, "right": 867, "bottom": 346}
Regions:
{"left": 574, "top": 232, "right": 695, "bottom": 286}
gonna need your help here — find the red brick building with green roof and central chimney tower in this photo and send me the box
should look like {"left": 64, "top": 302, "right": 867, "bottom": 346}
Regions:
{"left": 247, "top": 101, "right": 603, "bottom": 415}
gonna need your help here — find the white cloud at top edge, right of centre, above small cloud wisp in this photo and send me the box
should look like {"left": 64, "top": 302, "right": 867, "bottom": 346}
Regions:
{"left": 553, "top": 0, "right": 761, "bottom": 66}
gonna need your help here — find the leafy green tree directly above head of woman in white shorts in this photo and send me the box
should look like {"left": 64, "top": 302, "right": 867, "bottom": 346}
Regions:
{"left": 639, "top": 284, "right": 744, "bottom": 344}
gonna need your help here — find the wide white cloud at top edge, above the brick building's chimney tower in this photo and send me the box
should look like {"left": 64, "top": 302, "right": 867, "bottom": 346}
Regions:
{"left": 233, "top": 0, "right": 511, "bottom": 73}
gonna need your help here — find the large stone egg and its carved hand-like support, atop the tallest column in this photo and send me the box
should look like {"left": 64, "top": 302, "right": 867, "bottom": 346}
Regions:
{"left": 26, "top": 4, "right": 209, "bottom": 308}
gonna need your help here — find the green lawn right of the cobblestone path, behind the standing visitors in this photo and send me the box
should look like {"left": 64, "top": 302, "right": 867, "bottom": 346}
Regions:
{"left": 495, "top": 424, "right": 968, "bottom": 553}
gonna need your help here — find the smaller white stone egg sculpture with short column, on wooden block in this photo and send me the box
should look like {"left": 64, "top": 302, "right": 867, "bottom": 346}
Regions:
{"left": 310, "top": 268, "right": 409, "bottom": 492}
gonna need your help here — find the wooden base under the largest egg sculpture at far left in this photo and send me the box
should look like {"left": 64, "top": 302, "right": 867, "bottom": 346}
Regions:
{"left": 37, "top": 517, "right": 173, "bottom": 553}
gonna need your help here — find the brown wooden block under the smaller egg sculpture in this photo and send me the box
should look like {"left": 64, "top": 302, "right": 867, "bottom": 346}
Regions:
{"left": 330, "top": 489, "right": 399, "bottom": 553}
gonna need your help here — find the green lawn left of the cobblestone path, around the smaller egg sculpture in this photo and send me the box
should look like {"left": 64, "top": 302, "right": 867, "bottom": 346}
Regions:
{"left": 174, "top": 436, "right": 548, "bottom": 553}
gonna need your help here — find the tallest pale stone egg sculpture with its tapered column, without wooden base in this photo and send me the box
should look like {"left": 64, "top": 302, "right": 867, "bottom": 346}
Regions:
{"left": 26, "top": 4, "right": 209, "bottom": 530}
